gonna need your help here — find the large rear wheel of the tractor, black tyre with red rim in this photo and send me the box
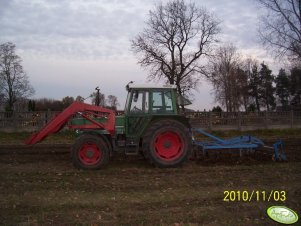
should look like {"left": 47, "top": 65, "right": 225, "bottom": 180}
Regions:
{"left": 142, "top": 120, "right": 192, "bottom": 168}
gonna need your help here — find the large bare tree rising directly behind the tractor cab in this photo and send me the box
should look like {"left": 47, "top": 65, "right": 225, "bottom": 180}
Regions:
{"left": 132, "top": 0, "right": 220, "bottom": 103}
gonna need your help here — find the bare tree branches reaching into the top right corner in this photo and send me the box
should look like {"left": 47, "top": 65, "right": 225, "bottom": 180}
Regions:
{"left": 257, "top": 0, "right": 301, "bottom": 60}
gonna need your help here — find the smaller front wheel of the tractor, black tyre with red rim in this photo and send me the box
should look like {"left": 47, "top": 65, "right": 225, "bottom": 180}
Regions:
{"left": 71, "top": 134, "right": 110, "bottom": 170}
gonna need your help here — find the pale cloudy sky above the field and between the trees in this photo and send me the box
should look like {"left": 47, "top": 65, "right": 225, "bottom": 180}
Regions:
{"left": 0, "top": 0, "right": 279, "bottom": 110}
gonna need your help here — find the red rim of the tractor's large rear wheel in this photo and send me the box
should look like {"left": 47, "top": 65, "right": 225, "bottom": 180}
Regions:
{"left": 154, "top": 131, "right": 184, "bottom": 161}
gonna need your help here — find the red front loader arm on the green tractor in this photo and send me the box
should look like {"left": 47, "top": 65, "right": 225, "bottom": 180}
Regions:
{"left": 24, "top": 102, "right": 115, "bottom": 145}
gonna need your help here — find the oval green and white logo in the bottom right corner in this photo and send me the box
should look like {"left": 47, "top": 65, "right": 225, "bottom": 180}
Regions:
{"left": 267, "top": 206, "right": 298, "bottom": 224}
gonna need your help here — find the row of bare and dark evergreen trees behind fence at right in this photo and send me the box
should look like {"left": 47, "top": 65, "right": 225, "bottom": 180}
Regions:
{"left": 208, "top": 44, "right": 301, "bottom": 112}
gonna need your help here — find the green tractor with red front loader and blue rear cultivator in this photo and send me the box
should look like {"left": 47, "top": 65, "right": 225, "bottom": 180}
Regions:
{"left": 25, "top": 83, "right": 287, "bottom": 170}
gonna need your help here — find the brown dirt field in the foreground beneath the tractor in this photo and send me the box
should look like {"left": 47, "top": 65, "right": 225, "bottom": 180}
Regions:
{"left": 0, "top": 139, "right": 301, "bottom": 226}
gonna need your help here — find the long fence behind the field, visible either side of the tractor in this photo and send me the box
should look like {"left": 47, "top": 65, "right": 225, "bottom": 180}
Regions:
{"left": 0, "top": 111, "right": 301, "bottom": 132}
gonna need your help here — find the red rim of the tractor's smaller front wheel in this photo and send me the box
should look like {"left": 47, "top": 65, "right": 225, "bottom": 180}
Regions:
{"left": 78, "top": 143, "right": 101, "bottom": 165}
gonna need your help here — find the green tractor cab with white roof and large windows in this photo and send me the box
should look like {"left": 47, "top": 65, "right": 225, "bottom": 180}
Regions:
{"left": 124, "top": 83, "right": 188, "bottom": 139}
